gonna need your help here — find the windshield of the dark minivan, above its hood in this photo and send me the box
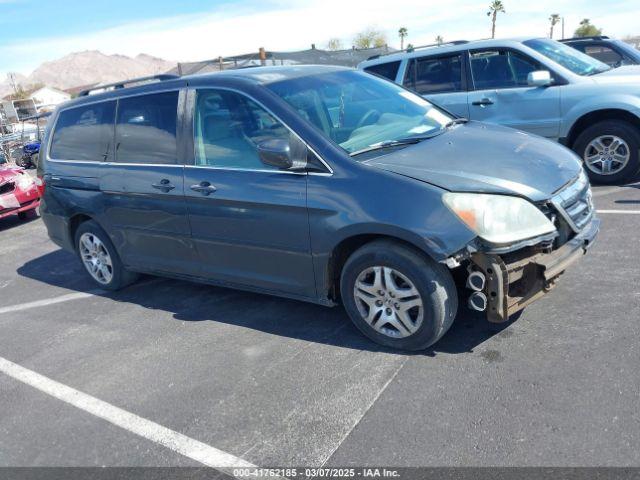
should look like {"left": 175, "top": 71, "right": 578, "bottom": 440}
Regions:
{"left": 267, "top": 70, "right": 452, "bottom": 153}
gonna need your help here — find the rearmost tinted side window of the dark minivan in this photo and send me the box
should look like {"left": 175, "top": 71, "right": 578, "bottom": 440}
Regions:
{"left": 49, "top": 102, "right": 116, "bottom": 162}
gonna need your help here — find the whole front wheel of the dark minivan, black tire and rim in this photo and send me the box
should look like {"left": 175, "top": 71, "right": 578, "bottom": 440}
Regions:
{"left": 340, "top": 240, "right": 458, "bottom": 350}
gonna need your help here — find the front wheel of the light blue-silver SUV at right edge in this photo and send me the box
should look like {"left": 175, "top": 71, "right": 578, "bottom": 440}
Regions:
{"left": 573, "top": 120, "right": 640, "bottom": 184}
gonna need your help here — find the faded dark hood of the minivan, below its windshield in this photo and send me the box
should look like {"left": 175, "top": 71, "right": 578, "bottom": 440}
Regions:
{"left": 363, "top": 122, "right": 582, "bottom": 202}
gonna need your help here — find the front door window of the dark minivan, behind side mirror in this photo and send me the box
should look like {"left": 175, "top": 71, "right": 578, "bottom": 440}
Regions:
{"left": 195, "top": 90, "right": 290, "bottom": 170}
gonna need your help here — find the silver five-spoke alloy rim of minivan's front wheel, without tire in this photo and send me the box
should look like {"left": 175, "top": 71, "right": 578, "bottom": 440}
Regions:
{"left": 353, "top": 266, "right": 424, "bottom": 338}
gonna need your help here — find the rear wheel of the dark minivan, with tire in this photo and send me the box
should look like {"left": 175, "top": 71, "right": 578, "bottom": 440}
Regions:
{"left": 75, "top": 220, "right": 138, "bottom": 290}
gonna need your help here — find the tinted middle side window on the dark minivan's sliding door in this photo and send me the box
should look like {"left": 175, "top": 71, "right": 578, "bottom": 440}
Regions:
{"left": 116, "top": 92, "right": 178, "bottom": 163}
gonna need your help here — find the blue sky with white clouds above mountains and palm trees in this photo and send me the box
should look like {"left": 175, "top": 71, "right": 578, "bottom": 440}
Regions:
{"left": 0, "top": 0, "right": 640, "bottom": 80}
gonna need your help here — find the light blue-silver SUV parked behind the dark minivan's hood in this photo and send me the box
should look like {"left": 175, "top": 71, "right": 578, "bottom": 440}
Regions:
{"left": 358, "top": 38, "right": 640, "bottom": 184}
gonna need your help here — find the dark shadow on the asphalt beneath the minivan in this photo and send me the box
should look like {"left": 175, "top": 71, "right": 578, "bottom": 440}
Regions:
{"left": 18, "top": 250, "right": 512, "bottom": 356}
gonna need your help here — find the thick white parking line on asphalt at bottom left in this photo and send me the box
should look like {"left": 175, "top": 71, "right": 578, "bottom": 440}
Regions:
{"left": 0, "top": 357, "right": 256, "bottom": 475}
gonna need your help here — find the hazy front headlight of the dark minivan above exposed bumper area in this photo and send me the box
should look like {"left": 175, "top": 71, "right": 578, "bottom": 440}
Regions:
{"left": 443, "top": 193, "right": 556, "bottom": 244}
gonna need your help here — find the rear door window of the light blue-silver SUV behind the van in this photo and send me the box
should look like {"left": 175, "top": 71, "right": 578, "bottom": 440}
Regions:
{"left": 404, "top": 55, "right": 462, "bottom": 95}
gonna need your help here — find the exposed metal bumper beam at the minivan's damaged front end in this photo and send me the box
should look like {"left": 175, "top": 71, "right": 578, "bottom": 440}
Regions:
{"left": 471, "top": 218, "right": 600, "bottom": 323}
